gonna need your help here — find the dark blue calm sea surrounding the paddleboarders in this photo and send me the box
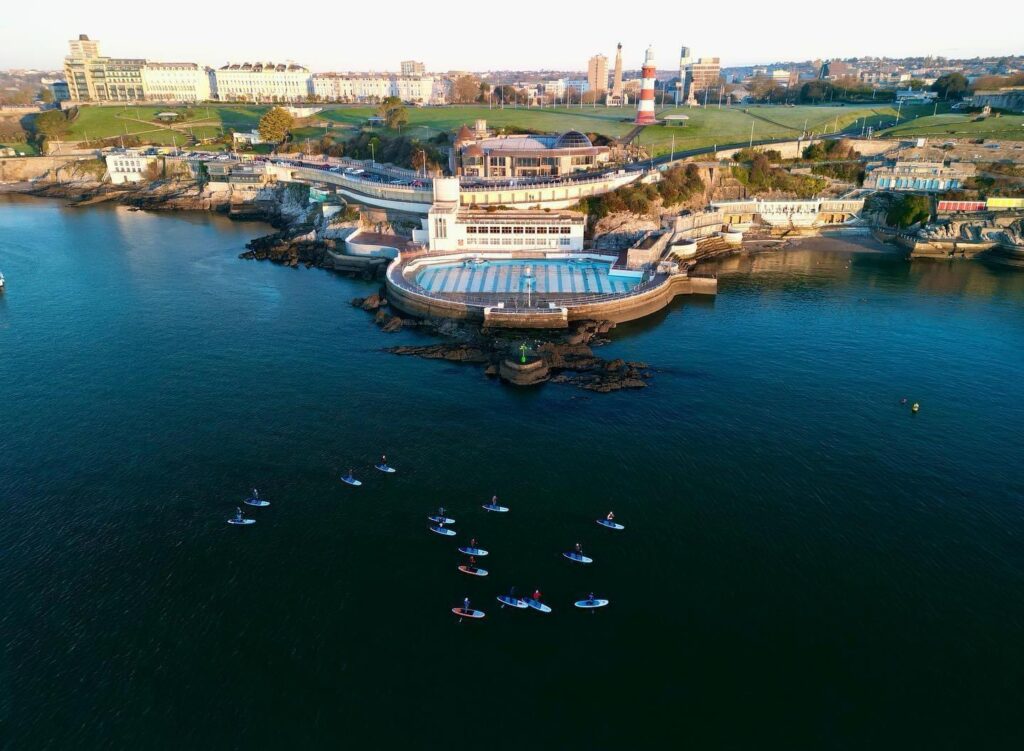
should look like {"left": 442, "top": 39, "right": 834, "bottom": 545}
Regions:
{"left": 0, "top": 198, "right": 1024, "bottom": 749}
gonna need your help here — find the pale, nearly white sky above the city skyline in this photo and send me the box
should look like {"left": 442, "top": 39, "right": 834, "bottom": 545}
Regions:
{"left": 0, "top": 0, "right": 1024, "bottom": 71}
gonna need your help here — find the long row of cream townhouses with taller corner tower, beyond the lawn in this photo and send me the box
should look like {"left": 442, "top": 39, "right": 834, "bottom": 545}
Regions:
{"left": 63, "top": 34, "right": 447, "bottom": 103}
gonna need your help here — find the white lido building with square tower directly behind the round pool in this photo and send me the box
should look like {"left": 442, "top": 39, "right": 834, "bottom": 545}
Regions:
{"left": 414, "top": 177, "right": 587, "bottom": 252}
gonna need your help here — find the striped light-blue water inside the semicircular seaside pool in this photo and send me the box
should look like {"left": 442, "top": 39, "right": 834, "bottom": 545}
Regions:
{"left": 416, "top": 260, "right": 640, "bottom": 295}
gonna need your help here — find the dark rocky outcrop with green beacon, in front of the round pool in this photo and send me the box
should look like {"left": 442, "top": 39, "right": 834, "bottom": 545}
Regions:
{"left": 351, "top": 290, "right": 653, "bottom": 393}
